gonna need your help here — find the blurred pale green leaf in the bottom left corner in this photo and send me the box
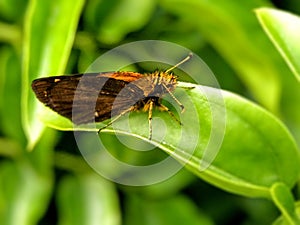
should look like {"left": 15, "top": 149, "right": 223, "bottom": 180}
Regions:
{"left": 0, "top": 161, "right": 51, "bottom": 225}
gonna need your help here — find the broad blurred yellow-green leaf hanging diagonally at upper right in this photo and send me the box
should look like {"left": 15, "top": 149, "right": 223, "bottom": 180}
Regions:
{"left": 160, "top": 0, "right": 281, "bottom": 113}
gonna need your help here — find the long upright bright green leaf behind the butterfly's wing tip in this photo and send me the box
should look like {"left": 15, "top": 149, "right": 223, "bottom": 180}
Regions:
{"left": 22, "top": 0, "right": 84, "bottom": 148}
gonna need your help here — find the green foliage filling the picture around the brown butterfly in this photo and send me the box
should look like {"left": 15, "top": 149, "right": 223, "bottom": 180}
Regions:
{"left": 0, "top": 0, "right": 300, "bottom": 225}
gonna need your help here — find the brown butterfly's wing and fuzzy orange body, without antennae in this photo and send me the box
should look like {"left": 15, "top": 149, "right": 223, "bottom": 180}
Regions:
{"left": 31, "top": 71, "right": 177, "bottom": 124}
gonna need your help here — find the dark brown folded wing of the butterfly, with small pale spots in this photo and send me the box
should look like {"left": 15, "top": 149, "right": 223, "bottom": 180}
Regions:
{"left": 32, "top": 72, "right": 143, "bottom": 124}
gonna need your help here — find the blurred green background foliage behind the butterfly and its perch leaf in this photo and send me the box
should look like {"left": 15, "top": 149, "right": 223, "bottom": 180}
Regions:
{"left": 0, "top": 0, "right": 300, "bottom": 225}
